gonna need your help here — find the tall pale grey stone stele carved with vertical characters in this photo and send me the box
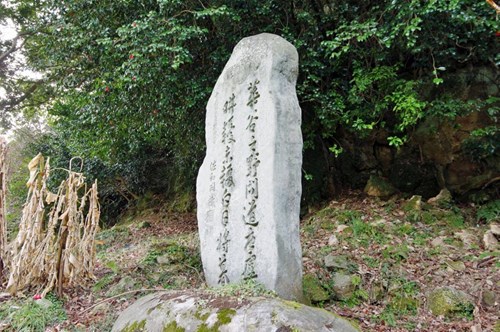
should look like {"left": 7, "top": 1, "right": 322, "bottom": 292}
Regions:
{"left": 197, "top": 33, "right": 303, "bottom": 301}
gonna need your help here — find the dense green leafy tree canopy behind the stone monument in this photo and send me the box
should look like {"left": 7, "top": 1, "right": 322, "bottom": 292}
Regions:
{"left": 0, "top": 0, "right": 500, "bottom": 223}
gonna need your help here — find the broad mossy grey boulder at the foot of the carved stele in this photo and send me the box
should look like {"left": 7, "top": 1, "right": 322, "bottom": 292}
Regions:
{"left": 112, "top": 291, "right": 359, "bottom": 332}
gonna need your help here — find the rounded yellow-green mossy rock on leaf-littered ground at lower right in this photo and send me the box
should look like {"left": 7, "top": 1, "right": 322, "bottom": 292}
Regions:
{"left": 427, "top": 287, "right": 474, "bottom": 317}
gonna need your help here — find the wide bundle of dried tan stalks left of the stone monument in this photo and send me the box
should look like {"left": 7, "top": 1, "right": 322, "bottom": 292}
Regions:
{"left": 7, "top": 154, "right": 100, "bottom": 296}
